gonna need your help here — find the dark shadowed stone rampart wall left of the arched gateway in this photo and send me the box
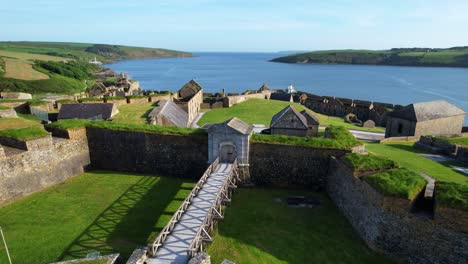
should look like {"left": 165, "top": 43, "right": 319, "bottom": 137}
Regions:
{"left": 87, "top": 128, "right": 208, "bottom": 179}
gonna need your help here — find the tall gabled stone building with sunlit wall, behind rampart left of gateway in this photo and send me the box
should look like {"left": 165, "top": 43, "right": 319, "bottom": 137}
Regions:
{"left": 174, "top": 80, "right": 203, "bottom": 124}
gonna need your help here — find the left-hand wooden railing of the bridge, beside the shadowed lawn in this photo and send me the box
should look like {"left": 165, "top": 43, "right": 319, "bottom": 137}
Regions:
{"left": 149, "top": 158, "right": 219, "bottom": 257}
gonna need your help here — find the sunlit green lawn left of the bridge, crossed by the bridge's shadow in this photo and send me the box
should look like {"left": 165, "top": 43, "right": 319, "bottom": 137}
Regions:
{"left": 0, "top": 171, "right": 194, "bottom": 264}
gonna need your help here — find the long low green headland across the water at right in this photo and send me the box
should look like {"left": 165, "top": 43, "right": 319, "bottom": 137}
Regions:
{"left": 271, "top": 46, "right": 468, "bottom": 67}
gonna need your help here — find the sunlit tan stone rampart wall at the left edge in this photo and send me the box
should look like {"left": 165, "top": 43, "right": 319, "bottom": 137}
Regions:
{"left": 0, "top": 137, "right": 90, "bottom": 204}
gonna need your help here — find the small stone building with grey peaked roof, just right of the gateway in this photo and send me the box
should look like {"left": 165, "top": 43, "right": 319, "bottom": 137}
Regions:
{"left": 270, "top": 106, "right": 309, "bottom": 137}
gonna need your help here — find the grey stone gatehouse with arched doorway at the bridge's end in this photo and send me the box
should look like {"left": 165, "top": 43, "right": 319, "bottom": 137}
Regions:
{"left": 207, "top": 117, "right": 253, "bottom": 181}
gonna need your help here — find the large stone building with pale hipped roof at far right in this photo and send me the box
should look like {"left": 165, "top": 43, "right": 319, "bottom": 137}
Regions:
{"left": 385, "top": 100, "right": 466, "bottom": 138}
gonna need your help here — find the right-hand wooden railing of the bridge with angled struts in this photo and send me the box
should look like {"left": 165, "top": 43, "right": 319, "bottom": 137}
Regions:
{"left": 187, "top": 159, "right": 239, "bottom": 258}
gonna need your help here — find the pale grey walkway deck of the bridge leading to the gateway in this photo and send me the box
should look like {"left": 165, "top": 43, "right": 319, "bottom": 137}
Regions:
{"left": 145, "top": 163, "right": 235, "bottom": 264}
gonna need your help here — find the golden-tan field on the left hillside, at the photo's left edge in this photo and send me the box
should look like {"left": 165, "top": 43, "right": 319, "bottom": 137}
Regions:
{"left": 3, "top": 58, "right": 49, "bottom": 80}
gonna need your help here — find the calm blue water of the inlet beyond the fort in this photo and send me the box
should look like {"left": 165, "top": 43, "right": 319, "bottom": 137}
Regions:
{"left": 106, "top": 52, "right": 468, "bottom": 111}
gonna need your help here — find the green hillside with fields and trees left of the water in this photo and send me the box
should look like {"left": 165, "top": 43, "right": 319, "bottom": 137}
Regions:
{"left": 0, "top": 42, "right": 192, "bottom": 94}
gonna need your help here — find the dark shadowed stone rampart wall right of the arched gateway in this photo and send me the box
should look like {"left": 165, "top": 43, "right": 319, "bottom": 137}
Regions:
{"left": 250, "top": 142, "right": 350, "bottom": 190}
